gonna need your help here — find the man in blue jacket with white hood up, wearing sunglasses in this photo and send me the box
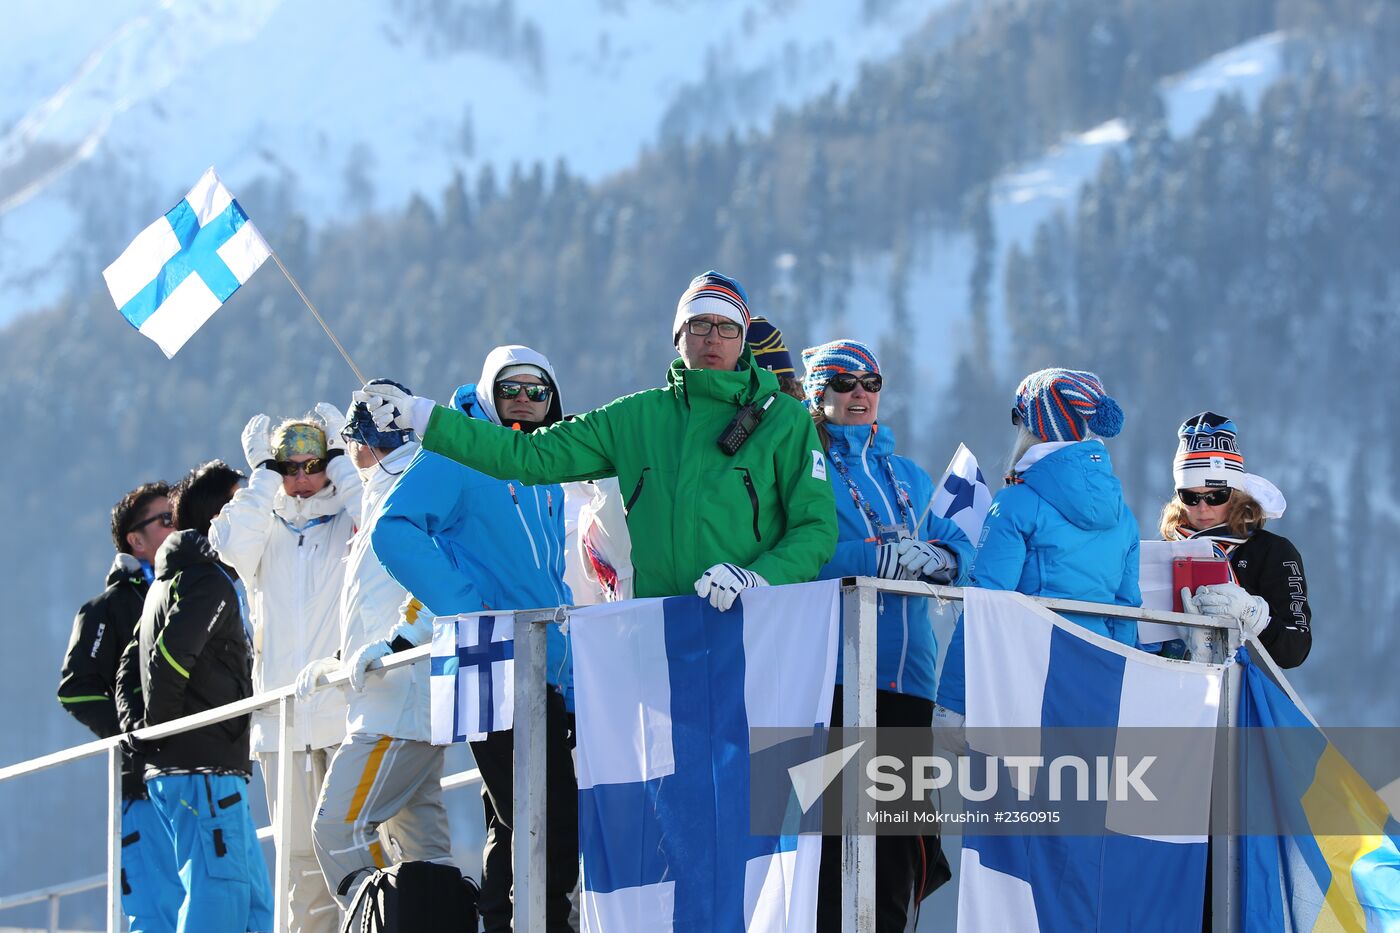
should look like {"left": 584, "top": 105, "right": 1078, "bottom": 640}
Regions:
{"left": 371, "top": 346, "right": 578, "bottom": 933}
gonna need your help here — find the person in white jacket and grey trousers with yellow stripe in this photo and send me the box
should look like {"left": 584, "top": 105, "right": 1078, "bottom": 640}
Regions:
{"left": 297, "top": 378, "right": 452, "bottom": 905}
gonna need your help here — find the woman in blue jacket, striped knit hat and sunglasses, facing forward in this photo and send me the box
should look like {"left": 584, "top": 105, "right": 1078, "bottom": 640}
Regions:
{"left": 802, "top": 340, "right": 972, "bottom": 933}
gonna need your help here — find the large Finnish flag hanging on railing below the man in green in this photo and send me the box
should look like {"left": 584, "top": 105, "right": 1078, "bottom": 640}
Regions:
{"left": 570, "top": 580, "right": 840, "bottom": 933}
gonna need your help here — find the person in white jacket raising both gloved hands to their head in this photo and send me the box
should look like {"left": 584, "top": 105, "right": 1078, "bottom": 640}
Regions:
{"left": 209, "top": 402, "right": 360, "bottom": 933}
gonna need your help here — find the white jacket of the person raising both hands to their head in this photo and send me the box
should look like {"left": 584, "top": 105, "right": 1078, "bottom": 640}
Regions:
{"left": 209, "top": 457, "right": 361, "bottom": 752}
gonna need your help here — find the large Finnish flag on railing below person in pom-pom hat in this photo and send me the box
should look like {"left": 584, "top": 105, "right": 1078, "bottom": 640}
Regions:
{"left": 958, "top": 588, "right": 1224, "bottom": 933}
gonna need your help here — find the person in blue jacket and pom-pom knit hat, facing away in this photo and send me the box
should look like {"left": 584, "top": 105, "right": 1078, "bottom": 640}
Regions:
{"left": 935, "top": 368, "right": 1142, "bottom": 730}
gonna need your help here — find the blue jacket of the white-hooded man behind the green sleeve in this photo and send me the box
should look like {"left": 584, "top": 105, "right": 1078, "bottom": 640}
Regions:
{"left": 371, "top": 385, "right": 574, "bottom": 706}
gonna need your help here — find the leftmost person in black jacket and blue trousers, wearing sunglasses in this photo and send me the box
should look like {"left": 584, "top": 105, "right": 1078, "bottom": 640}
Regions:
{"left": 59, "top": 482, "right": 183, "bottom": 933}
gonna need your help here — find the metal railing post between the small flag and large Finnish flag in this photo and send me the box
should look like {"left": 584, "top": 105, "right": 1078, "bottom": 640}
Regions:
{"left": 511, "top": 612, "right": 552, "bottom": 933}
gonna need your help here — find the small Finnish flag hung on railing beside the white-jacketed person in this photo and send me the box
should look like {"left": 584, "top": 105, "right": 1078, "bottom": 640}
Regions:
{"left": 428, "top": 612, "right": 515, "bottom": 745}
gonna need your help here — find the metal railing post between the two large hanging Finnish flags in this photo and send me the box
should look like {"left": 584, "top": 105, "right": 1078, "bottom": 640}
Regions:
{"left": 841, "top": 584, "right": 878, "bottom": 933}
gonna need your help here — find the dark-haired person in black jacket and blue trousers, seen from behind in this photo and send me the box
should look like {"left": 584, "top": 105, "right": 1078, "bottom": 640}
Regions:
{"left": 137, "top": 459, "right": 272, "bottom": 933}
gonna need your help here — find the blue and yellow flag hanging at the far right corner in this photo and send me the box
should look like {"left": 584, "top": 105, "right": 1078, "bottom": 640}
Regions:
{"left": 1236, "top": 650, "right": 1400, "bottom": 933}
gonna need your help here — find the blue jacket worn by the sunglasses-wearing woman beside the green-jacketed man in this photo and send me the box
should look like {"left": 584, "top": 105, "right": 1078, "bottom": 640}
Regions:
{"left": 818, "top": 423, "right": 973, "bottom": 700}
